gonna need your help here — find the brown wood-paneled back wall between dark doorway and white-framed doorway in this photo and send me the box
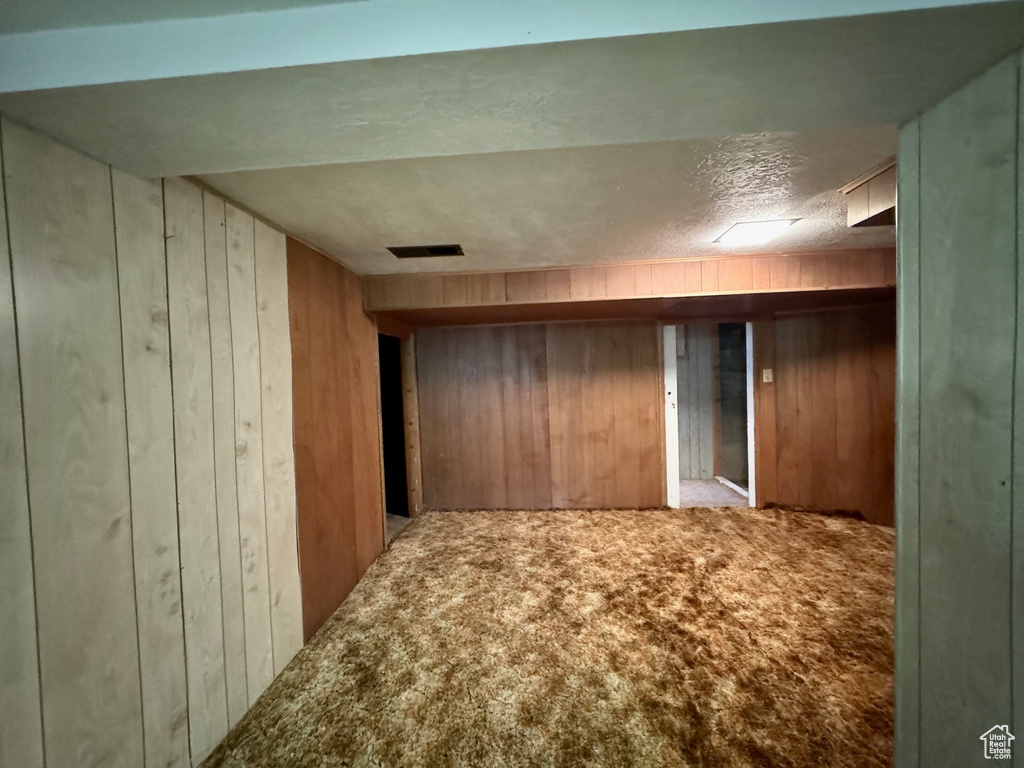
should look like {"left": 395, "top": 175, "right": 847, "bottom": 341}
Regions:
{"left": 416, "top": 324, "right": 665, "bottom": 509}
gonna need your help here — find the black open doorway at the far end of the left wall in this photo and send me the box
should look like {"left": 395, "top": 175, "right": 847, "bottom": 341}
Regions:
{"left": 377, "top": 334, "right": 409, "bottom": 517}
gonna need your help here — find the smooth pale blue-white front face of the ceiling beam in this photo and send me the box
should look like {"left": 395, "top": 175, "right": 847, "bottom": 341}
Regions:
{"left": 0, "top": 0, "right": 1015, "bottom": 92}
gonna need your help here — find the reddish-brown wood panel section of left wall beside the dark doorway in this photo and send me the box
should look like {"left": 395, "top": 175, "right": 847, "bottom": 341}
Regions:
{"left": 288, "top": 240, "right": 384, "bottom": 638}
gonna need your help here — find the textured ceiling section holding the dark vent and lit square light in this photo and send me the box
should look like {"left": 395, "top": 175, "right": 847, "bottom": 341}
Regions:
{"left": 202, "top": 127, "right": 896, "bottom": 273}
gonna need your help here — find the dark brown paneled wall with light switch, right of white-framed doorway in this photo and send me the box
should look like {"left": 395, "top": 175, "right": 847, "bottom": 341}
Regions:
{"left": 754, "top": 304, "right": 896, "bottom": 525}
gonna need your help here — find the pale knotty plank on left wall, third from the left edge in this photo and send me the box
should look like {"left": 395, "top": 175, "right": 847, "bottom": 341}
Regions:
{"left": 111, "top": 171, "right": 189, "bottom": 766}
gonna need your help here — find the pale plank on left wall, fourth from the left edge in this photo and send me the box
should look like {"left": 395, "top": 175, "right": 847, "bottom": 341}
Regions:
{"left": 164, "top": 179, "right": 227, "bottom": 761}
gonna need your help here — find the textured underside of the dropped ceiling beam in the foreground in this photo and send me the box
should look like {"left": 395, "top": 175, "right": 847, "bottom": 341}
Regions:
{"left": 0, "top": 2, "right": 1024, "bottom": 176}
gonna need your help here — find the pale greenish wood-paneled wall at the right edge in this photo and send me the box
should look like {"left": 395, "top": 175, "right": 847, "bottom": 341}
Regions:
{"left": 895, "top": 52, "right": 1024, "bottom": 768}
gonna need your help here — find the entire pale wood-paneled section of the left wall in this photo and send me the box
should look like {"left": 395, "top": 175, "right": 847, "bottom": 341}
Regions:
{"left": 0, "top": 120, "right": 302, "bottom": 768}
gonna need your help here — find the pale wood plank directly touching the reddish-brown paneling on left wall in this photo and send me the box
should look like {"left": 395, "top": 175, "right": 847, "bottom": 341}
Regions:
{"left": 255, "top": 221, "right": 302, "bottom": 674}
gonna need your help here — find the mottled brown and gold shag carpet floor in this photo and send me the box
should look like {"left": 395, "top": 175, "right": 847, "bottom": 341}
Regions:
{"left": 205, "top": 509, "right": 893, "bottom": 768}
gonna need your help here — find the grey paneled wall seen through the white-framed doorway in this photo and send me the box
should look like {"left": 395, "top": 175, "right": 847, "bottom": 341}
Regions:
{"left": 676, "top": 324, "right": 718, "bottom": 480}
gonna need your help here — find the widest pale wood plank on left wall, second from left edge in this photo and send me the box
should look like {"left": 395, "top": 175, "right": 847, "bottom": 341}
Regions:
{"left": 2, "top": 115, "right": 143, "bottom": 768}
